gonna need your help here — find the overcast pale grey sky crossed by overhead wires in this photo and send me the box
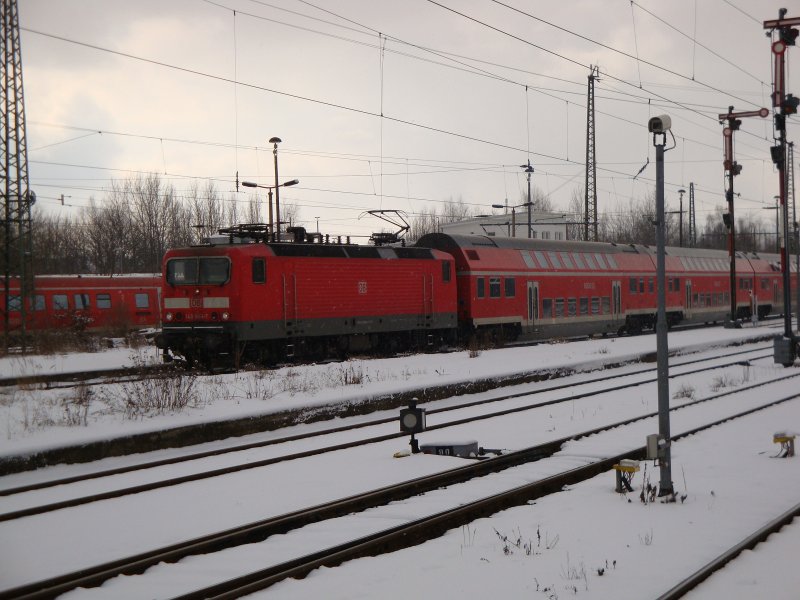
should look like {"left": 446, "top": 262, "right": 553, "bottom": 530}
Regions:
{"left": 19, "top": 0, "right": 800, "bottom": 235}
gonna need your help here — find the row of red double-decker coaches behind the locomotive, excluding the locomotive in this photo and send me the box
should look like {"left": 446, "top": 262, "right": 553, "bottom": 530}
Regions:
{"left": 417, "top": 233, "right": 782, "bottom": 340}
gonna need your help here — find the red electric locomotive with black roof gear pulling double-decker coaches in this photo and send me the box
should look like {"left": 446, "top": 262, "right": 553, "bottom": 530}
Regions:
{"left": 156, "top": 226, "right": 456, "bottom": 365}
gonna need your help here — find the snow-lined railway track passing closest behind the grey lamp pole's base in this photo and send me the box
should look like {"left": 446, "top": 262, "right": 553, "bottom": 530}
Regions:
{"left": 0, "top": 356, "right": 797, "bottom": 598}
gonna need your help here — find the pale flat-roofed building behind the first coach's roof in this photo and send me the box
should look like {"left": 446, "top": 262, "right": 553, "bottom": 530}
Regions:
{"left": 439, "top": 210, "right": 569, "bottom": 240}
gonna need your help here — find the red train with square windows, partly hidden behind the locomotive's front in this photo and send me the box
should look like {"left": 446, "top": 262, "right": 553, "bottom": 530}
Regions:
{"left": 0, "top": 273, "right": 161, "bottom": 336}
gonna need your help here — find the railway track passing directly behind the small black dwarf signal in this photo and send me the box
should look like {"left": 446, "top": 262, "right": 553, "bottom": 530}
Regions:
{"left": 0, "top": 349, "right": 780, "bottom": 522}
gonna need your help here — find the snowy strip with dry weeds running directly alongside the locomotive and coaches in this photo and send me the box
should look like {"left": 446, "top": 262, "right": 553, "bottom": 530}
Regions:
{"left": 0, "top": 325, "right": 780, "bottom": 456}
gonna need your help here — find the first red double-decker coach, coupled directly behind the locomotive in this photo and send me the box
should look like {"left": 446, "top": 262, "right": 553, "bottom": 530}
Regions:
{"left": 417, "top": 233, "right": 636, "bottom": 339}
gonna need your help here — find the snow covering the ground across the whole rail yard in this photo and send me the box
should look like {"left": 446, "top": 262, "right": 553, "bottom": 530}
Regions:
{"left": 0, "top": 326, "right": 800, "bottom": 600}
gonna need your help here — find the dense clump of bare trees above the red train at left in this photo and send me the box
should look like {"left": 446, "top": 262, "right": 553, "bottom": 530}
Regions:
{"left": 32, "top": 174, "right": 297, "bottom": 275}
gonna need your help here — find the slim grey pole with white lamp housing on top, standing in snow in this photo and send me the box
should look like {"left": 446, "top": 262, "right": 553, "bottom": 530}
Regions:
{"left": 653, "top": 133, "right": 674, "bottom": 496}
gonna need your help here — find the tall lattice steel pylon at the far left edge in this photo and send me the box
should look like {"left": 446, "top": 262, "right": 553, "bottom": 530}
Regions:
{"left": 0, "top": 0, "right": 35, "bottom": 351}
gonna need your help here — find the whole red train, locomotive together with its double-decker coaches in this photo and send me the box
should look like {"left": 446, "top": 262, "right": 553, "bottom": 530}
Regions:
{"left": 156, "top": 226, "right": 797, "bottom": 366}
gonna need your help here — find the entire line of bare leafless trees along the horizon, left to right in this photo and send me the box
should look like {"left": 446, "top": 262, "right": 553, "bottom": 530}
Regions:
{"left": 23, "top": 174, "right": 788, "bottom": 274}
